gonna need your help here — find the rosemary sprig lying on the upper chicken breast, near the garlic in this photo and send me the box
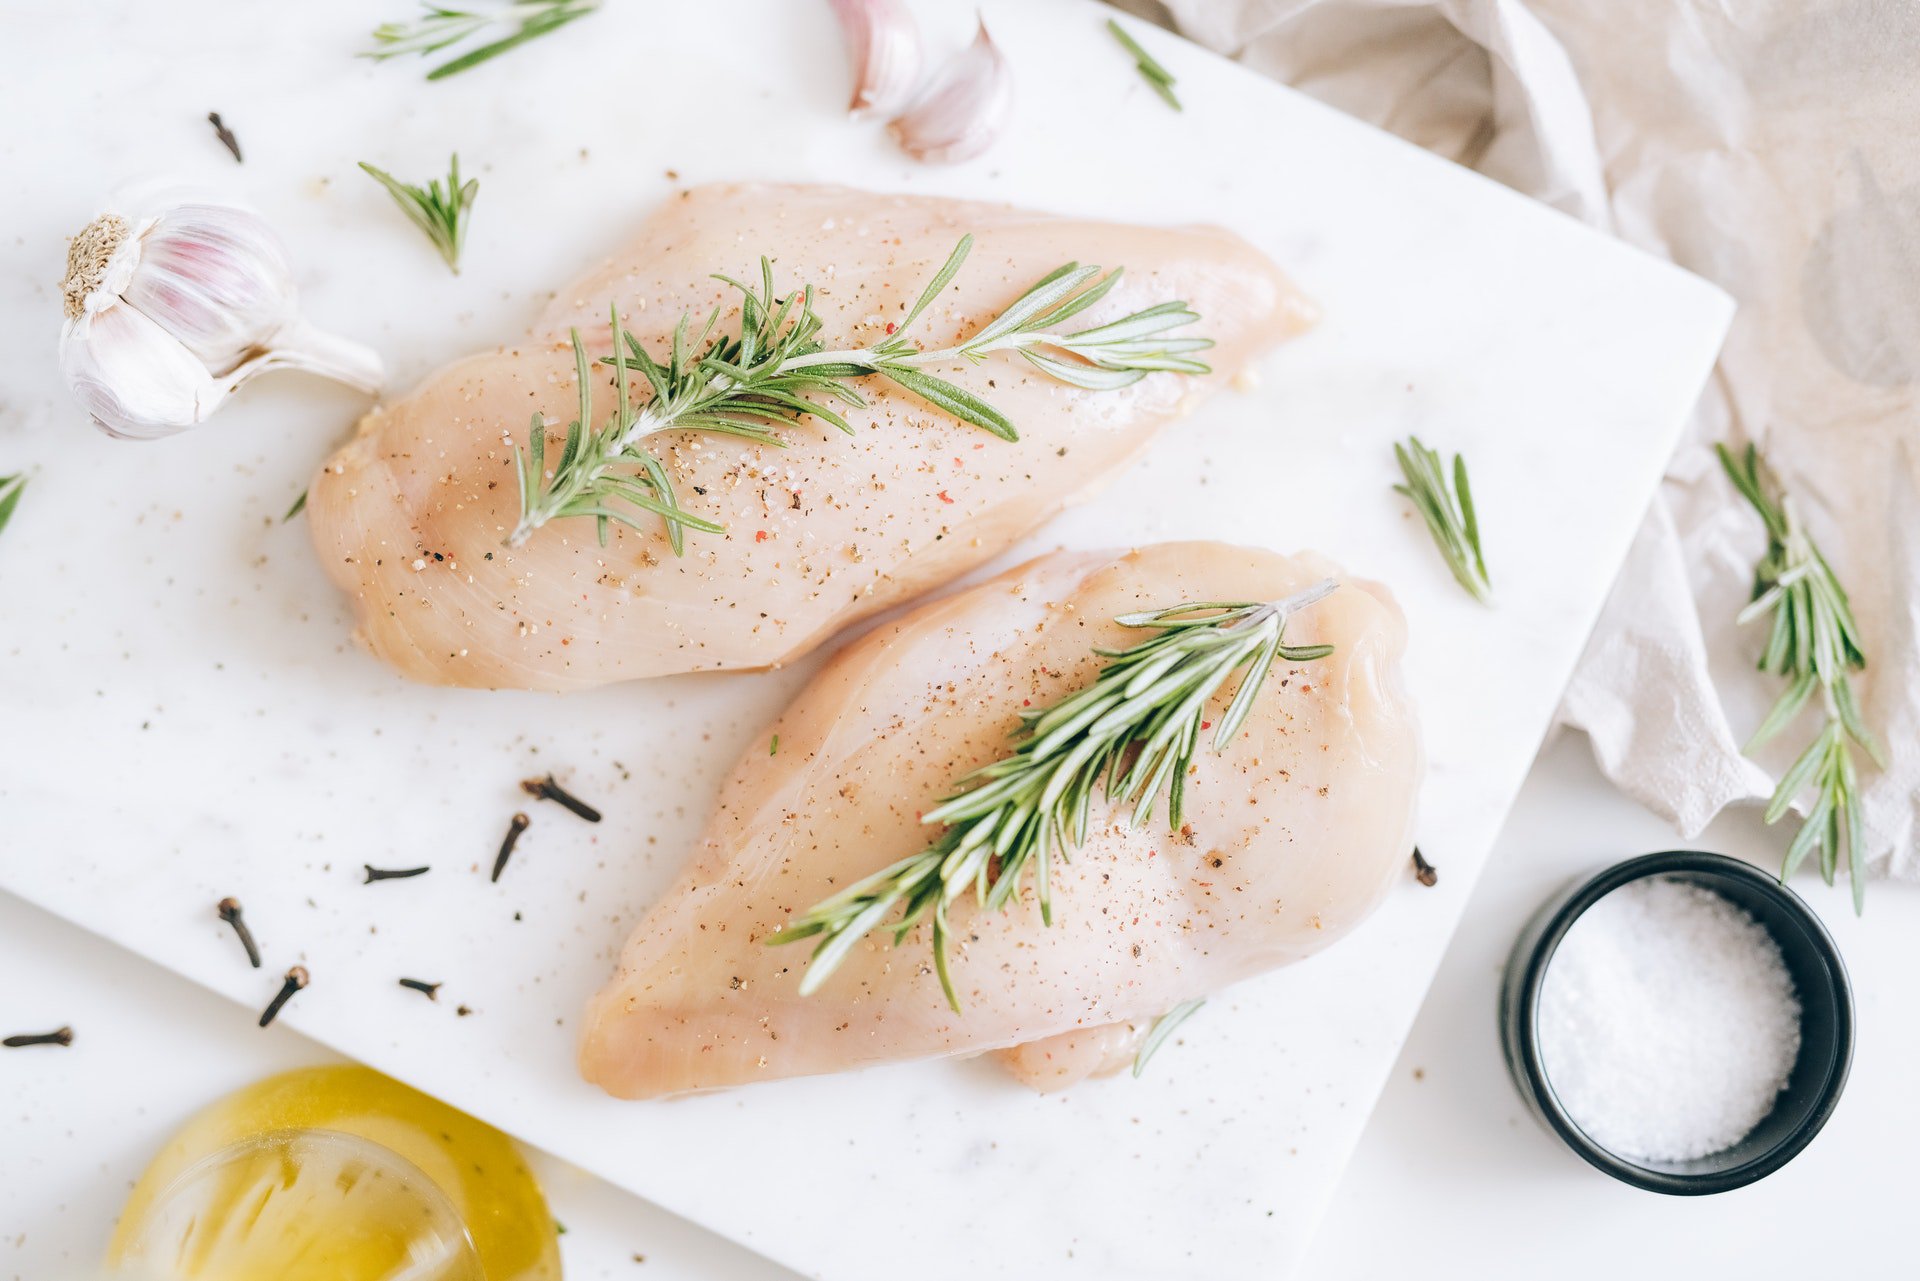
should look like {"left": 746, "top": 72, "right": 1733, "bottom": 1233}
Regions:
{"left": 507, "top": 236, "right": 1213, "bottom": 555}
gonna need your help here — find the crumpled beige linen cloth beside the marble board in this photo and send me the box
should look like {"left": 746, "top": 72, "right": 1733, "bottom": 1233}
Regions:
{"left": 1123, "top": 0, "right": 1920, "bottom": 880}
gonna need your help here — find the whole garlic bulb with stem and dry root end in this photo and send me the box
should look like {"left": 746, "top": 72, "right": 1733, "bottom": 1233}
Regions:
{"left": 60, "top": 192, "right": 382, "bottom": 440}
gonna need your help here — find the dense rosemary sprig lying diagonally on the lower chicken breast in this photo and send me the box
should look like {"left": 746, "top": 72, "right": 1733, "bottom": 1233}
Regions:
{"left": 768, "top": 580, "right": 1336, "bottom": 1010}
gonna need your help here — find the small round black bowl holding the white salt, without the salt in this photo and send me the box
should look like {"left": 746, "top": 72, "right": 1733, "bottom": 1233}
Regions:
{"left": 1500, "top": 849, "right": 1853, "bottom": 1196}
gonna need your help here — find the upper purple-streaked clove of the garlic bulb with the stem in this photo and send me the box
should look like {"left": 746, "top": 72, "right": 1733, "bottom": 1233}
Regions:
{"left": 121, "top": 204, "right": 296, "bottom": 376}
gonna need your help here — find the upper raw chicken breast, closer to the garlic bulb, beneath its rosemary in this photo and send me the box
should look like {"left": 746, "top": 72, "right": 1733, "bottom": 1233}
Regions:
{"left": 307, "top": 186, "right": 1309, "bottom": 689}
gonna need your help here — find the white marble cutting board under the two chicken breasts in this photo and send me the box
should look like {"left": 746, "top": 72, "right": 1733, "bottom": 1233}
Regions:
{"left": 0, "top": 0, "right": 1730, "bottom": 1281}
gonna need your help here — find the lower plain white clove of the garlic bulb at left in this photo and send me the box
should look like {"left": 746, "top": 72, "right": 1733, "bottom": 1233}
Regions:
{"left": 60, "top": 303, "right": 227, "bottom": 440}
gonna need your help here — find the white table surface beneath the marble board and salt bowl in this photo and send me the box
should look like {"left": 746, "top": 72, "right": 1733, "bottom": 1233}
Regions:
{"left": 11, "top": 736, "right": 1920, "bottom": 1281}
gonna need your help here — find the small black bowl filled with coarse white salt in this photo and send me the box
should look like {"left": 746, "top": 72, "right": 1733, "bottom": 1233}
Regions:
{"left": 1500, "top": 851, "right": 1853, "bottom": 1196}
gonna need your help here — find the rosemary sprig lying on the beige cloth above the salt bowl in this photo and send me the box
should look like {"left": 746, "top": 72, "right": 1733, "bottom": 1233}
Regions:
{"left": 1715, "top": 446, "right": 1885, "bottom": 912}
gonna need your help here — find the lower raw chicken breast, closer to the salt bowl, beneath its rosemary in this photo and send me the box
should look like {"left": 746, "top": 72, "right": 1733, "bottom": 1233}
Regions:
{"left": 580, "top": 544, "right": 1423, "bottom": 1099}
